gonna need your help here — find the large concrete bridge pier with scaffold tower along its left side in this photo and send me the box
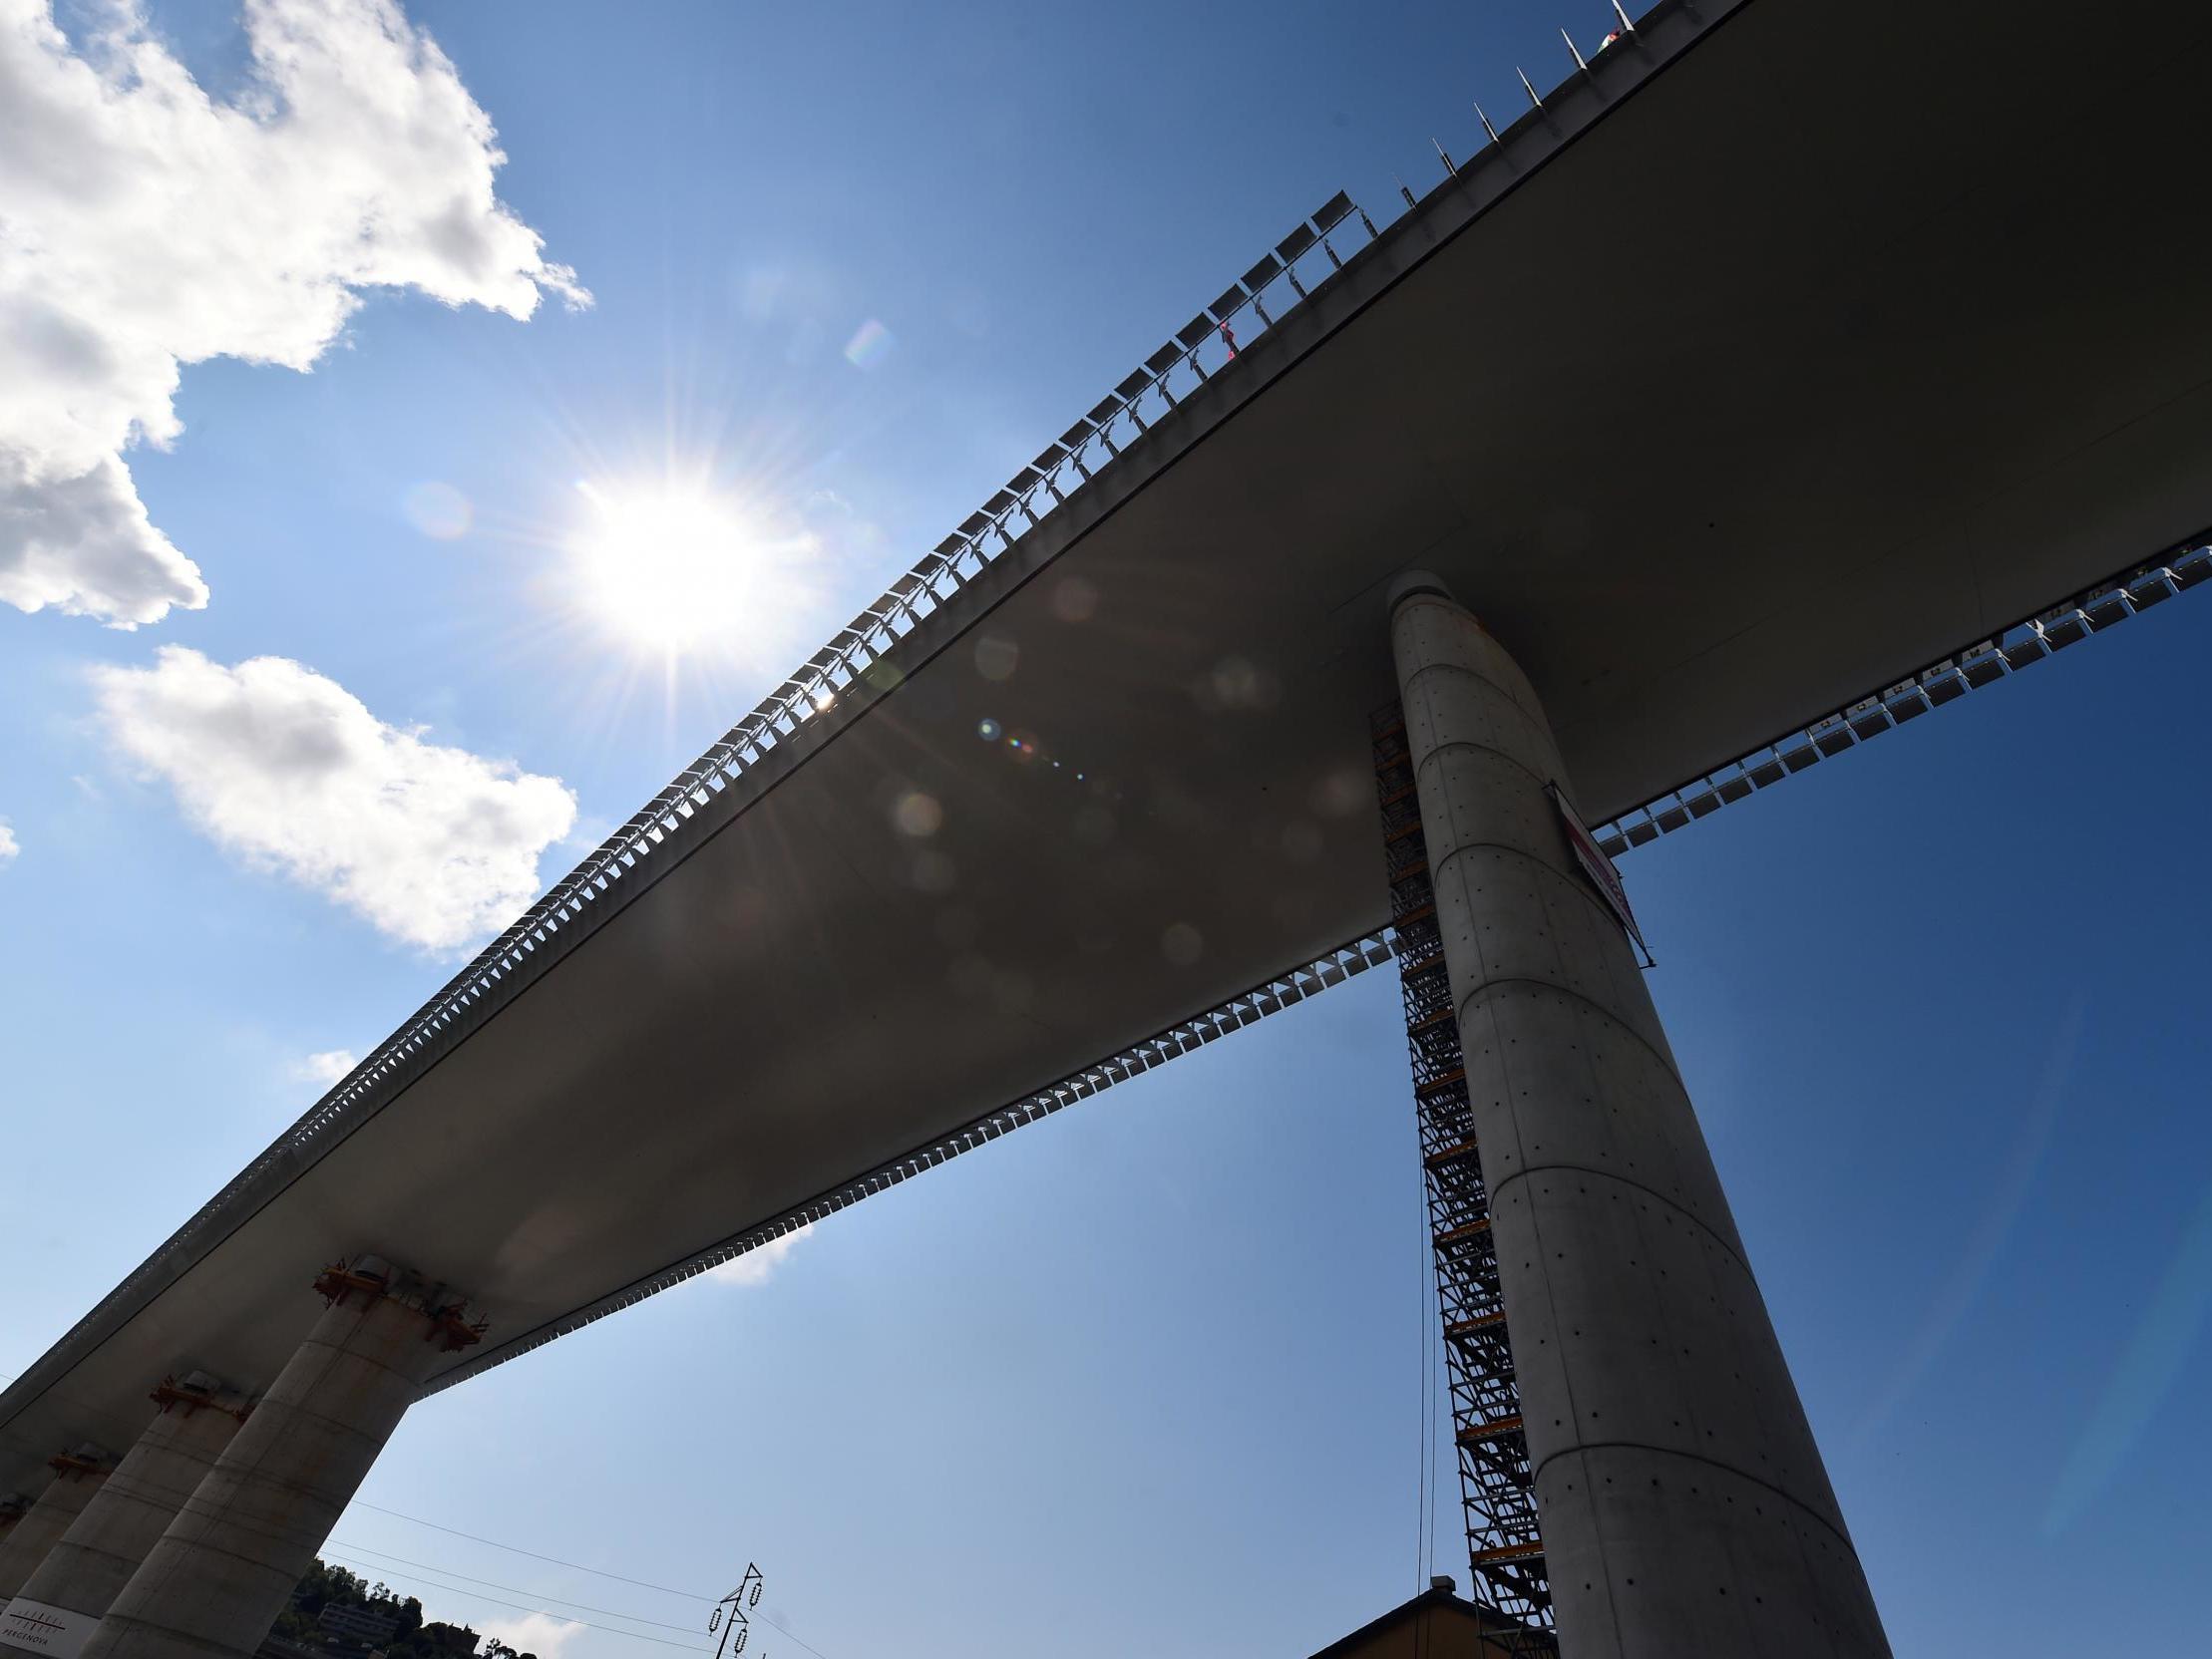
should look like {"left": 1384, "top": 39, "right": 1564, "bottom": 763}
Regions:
{"left": 1391, "top": 575, "right": 1889, "bottom": 1659}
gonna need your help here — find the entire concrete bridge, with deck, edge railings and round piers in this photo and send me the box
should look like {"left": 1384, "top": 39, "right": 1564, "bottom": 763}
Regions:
{"left": 0, "top": 0, "right": 2212, "bottom": 1659}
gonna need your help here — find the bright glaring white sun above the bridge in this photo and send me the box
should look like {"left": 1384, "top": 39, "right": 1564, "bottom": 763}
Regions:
{"left": 568, "top": 483, "right": 792, "bottom": 655}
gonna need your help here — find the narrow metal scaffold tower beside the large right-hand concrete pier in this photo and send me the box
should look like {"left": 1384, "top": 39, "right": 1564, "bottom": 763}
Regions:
{"left": 1371, "top": 704, "right": 1555, "bottom": 1652}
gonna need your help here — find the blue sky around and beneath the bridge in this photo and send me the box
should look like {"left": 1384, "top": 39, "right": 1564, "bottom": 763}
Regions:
{"left": 0, "top": 0, "right": 2212, "bottom": 1659}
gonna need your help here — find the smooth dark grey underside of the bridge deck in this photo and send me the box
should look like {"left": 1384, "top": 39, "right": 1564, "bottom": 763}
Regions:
{"left": 0, "top": 0, "right": 2212, "bottom": 1489}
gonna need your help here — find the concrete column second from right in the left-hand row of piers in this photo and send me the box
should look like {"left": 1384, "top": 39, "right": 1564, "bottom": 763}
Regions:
{"left": 0, "top": 1372, "right": 247, "bottom": 1659}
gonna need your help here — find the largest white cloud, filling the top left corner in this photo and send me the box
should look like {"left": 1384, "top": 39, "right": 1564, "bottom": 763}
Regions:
{"left": 0, "top": 0, "right": 590, "bottom": 628}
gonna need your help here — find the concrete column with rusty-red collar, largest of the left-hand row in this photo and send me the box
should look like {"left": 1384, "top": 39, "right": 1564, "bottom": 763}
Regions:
{"left": 82, "top": 1256, "right": 483, "bottom": 1659}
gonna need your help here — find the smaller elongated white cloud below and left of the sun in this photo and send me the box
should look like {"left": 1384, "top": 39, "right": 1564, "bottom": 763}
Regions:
{"left": 93, "top": 646, "right": 575, "bottom": 951}
